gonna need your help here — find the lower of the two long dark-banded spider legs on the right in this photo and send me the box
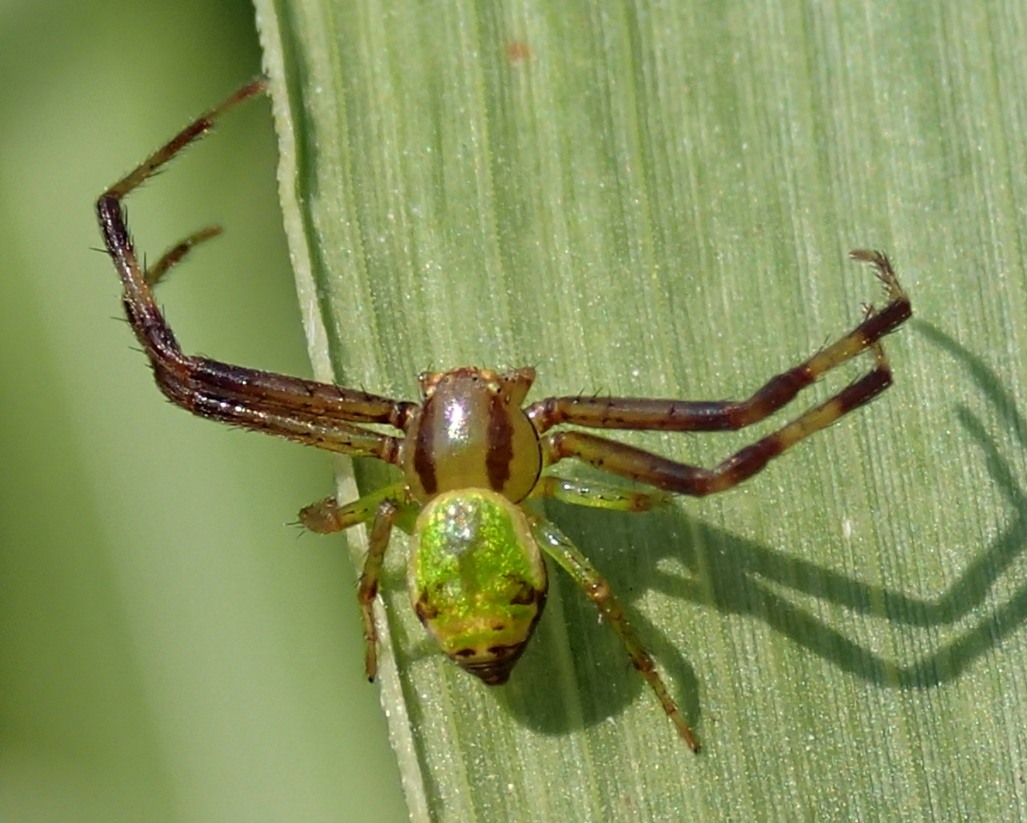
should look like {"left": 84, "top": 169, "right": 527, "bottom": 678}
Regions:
{"left": 542, "top": 343, "right": 891, "bottom": 497}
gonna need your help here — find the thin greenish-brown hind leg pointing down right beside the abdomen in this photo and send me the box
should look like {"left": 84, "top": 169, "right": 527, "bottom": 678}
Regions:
{"left": 531, "top": 518, "right": 699, "bottom": 752}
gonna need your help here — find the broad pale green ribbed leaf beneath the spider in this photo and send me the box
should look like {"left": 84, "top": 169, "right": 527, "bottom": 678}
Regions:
{"left": 257, "top": 0, "right": 1027, "bottom": 821}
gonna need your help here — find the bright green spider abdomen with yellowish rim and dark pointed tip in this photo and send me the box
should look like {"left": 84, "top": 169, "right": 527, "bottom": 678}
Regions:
{"left": 410, "top": 489, "right": 548, "bottom": 685}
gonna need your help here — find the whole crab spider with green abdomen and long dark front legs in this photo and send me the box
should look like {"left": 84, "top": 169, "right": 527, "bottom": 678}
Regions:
{"left": 97, "top": 78, "right": 911, "bottom": 751}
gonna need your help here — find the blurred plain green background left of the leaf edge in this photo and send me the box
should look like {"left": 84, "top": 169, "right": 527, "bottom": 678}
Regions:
{"left": 0, "top": 0, "right": 406, "bottom": 821}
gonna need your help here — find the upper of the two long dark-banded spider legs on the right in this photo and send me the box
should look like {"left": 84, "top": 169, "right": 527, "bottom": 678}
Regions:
{"left": 527, "top": 250, "right": 911, "bottom": 433}
